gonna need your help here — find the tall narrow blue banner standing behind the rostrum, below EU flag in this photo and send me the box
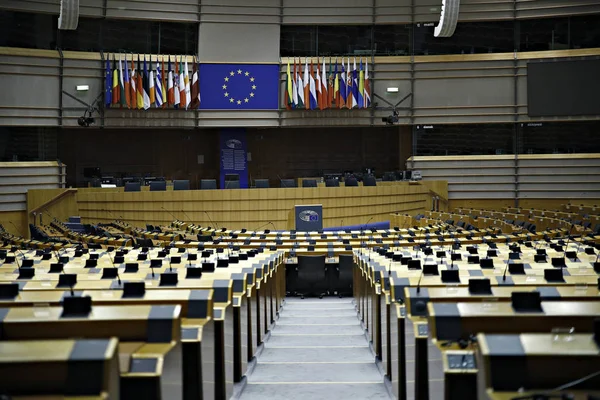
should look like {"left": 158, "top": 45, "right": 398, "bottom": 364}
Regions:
{"left": 219, "top": 129, "right": 248, "bottom": 189}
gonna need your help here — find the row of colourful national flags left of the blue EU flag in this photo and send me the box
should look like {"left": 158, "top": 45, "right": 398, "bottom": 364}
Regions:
{"left": 104, "top": 55, "right": 200, "bottom": 110}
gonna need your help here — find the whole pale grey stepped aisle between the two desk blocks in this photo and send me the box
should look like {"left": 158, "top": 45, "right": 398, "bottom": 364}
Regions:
{"left": 240, "top": 298, "right": 390, "bottom": 400}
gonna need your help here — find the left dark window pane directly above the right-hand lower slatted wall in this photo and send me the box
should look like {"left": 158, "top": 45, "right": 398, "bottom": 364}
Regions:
{"left": 416, "top": 124, "right": 514, "bottom": 156}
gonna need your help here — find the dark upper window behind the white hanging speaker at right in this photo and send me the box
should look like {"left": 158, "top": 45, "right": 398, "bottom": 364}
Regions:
{"left": 414, "top": 21, "right": 515, "bottom": 55}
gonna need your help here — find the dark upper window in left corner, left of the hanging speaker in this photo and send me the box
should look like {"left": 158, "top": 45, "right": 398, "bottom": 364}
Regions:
{"left": 0, "top": 10, "right": 58, "bottom": 50}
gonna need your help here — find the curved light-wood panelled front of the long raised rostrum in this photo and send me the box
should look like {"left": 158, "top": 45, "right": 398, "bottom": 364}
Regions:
{"left": 72, "top": 182, "right": 442, "bottom": 229}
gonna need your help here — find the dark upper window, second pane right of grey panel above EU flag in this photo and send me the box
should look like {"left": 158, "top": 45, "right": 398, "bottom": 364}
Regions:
{"left": 317, "top": 25, "right": 372, "bottom": 56}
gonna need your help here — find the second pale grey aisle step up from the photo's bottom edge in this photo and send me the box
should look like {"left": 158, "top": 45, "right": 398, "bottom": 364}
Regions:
{"left": 249, "top": 360, "right": 383, "bottom": 383}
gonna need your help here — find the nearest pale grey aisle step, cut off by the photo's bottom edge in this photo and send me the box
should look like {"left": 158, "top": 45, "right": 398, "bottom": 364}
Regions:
{"left": 241, "top": 383, "right": 390, "bottom": 400}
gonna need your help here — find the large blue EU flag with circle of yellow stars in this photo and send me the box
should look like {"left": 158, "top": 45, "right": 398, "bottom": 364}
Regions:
{"left": 200, "top": 64, "right": 279, "bottom": 110}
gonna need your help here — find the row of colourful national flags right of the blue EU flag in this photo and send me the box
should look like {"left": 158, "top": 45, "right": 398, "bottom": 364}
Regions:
{"left": 284, "top": 57, "right": 371, "bottom": 110}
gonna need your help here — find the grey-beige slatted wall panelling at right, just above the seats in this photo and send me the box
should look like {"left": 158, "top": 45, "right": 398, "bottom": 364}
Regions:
{"left": 411, "top": 154, "right": 600, "bottom": 208}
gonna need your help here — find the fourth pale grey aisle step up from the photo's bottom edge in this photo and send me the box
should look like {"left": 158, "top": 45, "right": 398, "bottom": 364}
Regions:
{"left": 265, "top": 333, "right": 369, "bottom": 348}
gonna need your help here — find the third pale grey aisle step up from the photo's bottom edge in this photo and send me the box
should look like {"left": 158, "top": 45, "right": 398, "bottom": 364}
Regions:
{"left": 258, "top": 346, "right": 375, "bottom": 364}
